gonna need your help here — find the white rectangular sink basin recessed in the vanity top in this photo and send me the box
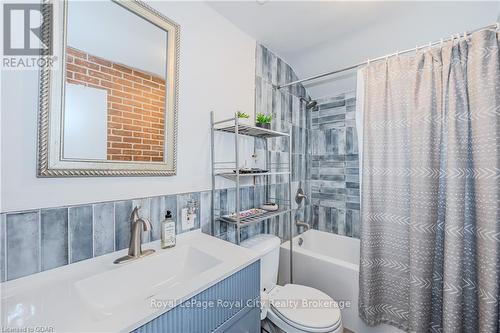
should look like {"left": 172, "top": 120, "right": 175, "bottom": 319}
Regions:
{"left": 75, "top": 246, "right": 222, "bottom": 315}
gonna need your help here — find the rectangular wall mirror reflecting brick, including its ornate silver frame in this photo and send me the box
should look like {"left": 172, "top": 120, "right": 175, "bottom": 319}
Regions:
{"left": 38, "top": 1, "right": 180, "bottom": 177}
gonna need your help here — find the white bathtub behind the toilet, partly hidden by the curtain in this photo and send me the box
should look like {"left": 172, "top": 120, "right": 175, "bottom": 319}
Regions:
{"left": 278, "top": 230, "right": 402, "bottom": 333}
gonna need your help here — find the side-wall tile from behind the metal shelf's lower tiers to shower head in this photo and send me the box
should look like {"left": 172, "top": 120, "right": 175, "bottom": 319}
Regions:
{"left": 204, "top": 45, "right": 311, "bottom": 242}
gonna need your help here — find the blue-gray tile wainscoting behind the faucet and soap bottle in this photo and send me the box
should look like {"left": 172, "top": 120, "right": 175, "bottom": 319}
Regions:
{"left": 0, "top": 191, "right": 205, "bottom": 281}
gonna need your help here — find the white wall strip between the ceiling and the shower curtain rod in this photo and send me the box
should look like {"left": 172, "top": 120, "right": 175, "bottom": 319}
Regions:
{"left": 285, "top": 1, "right": 500, "bottom": 98}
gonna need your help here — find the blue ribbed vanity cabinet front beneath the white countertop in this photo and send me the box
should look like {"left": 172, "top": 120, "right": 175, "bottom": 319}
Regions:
{"left": 134, "top": 261, "right": 260, "bottom": 333}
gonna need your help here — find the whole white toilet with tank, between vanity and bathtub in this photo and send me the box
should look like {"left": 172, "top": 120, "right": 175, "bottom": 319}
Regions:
{"left": 241, "top": 235, "right": 343, "bottom": 333}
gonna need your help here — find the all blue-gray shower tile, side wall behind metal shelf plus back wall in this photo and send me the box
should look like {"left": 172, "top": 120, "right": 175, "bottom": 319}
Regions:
{"left": 204, "top": 45, "right": 360, "bottom": 242}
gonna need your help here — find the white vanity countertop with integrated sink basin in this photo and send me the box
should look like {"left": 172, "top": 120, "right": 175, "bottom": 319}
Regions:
{"left": 1, "top": 230, "right": 259, "bottom": 332}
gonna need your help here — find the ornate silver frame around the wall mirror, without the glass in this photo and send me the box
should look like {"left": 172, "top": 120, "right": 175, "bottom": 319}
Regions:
{"left": 37, "top": 0, "right": 180, "bottom": 177}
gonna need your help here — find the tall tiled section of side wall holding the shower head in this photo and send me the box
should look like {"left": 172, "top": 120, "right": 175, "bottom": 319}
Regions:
{"left": 255, "top": 45, "right": 311, "bottom": 240}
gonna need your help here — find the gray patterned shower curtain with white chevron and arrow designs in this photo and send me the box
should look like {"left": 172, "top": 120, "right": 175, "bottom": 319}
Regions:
{"left": 359, "top": 30, "right": 500, "bottom": 333}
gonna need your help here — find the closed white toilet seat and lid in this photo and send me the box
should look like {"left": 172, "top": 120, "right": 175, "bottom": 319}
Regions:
{"left": 268, "top": 284, "right": 342, "bottom": 333}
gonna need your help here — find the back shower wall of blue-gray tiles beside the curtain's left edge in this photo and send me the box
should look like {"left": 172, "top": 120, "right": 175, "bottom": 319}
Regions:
{"left": 310, "top": 92, "right": 360, "bottom": 238}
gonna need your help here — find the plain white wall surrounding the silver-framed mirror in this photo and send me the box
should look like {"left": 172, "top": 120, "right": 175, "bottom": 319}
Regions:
{"left": 1, "top": 2, "right": 255, "bottom": 212}
